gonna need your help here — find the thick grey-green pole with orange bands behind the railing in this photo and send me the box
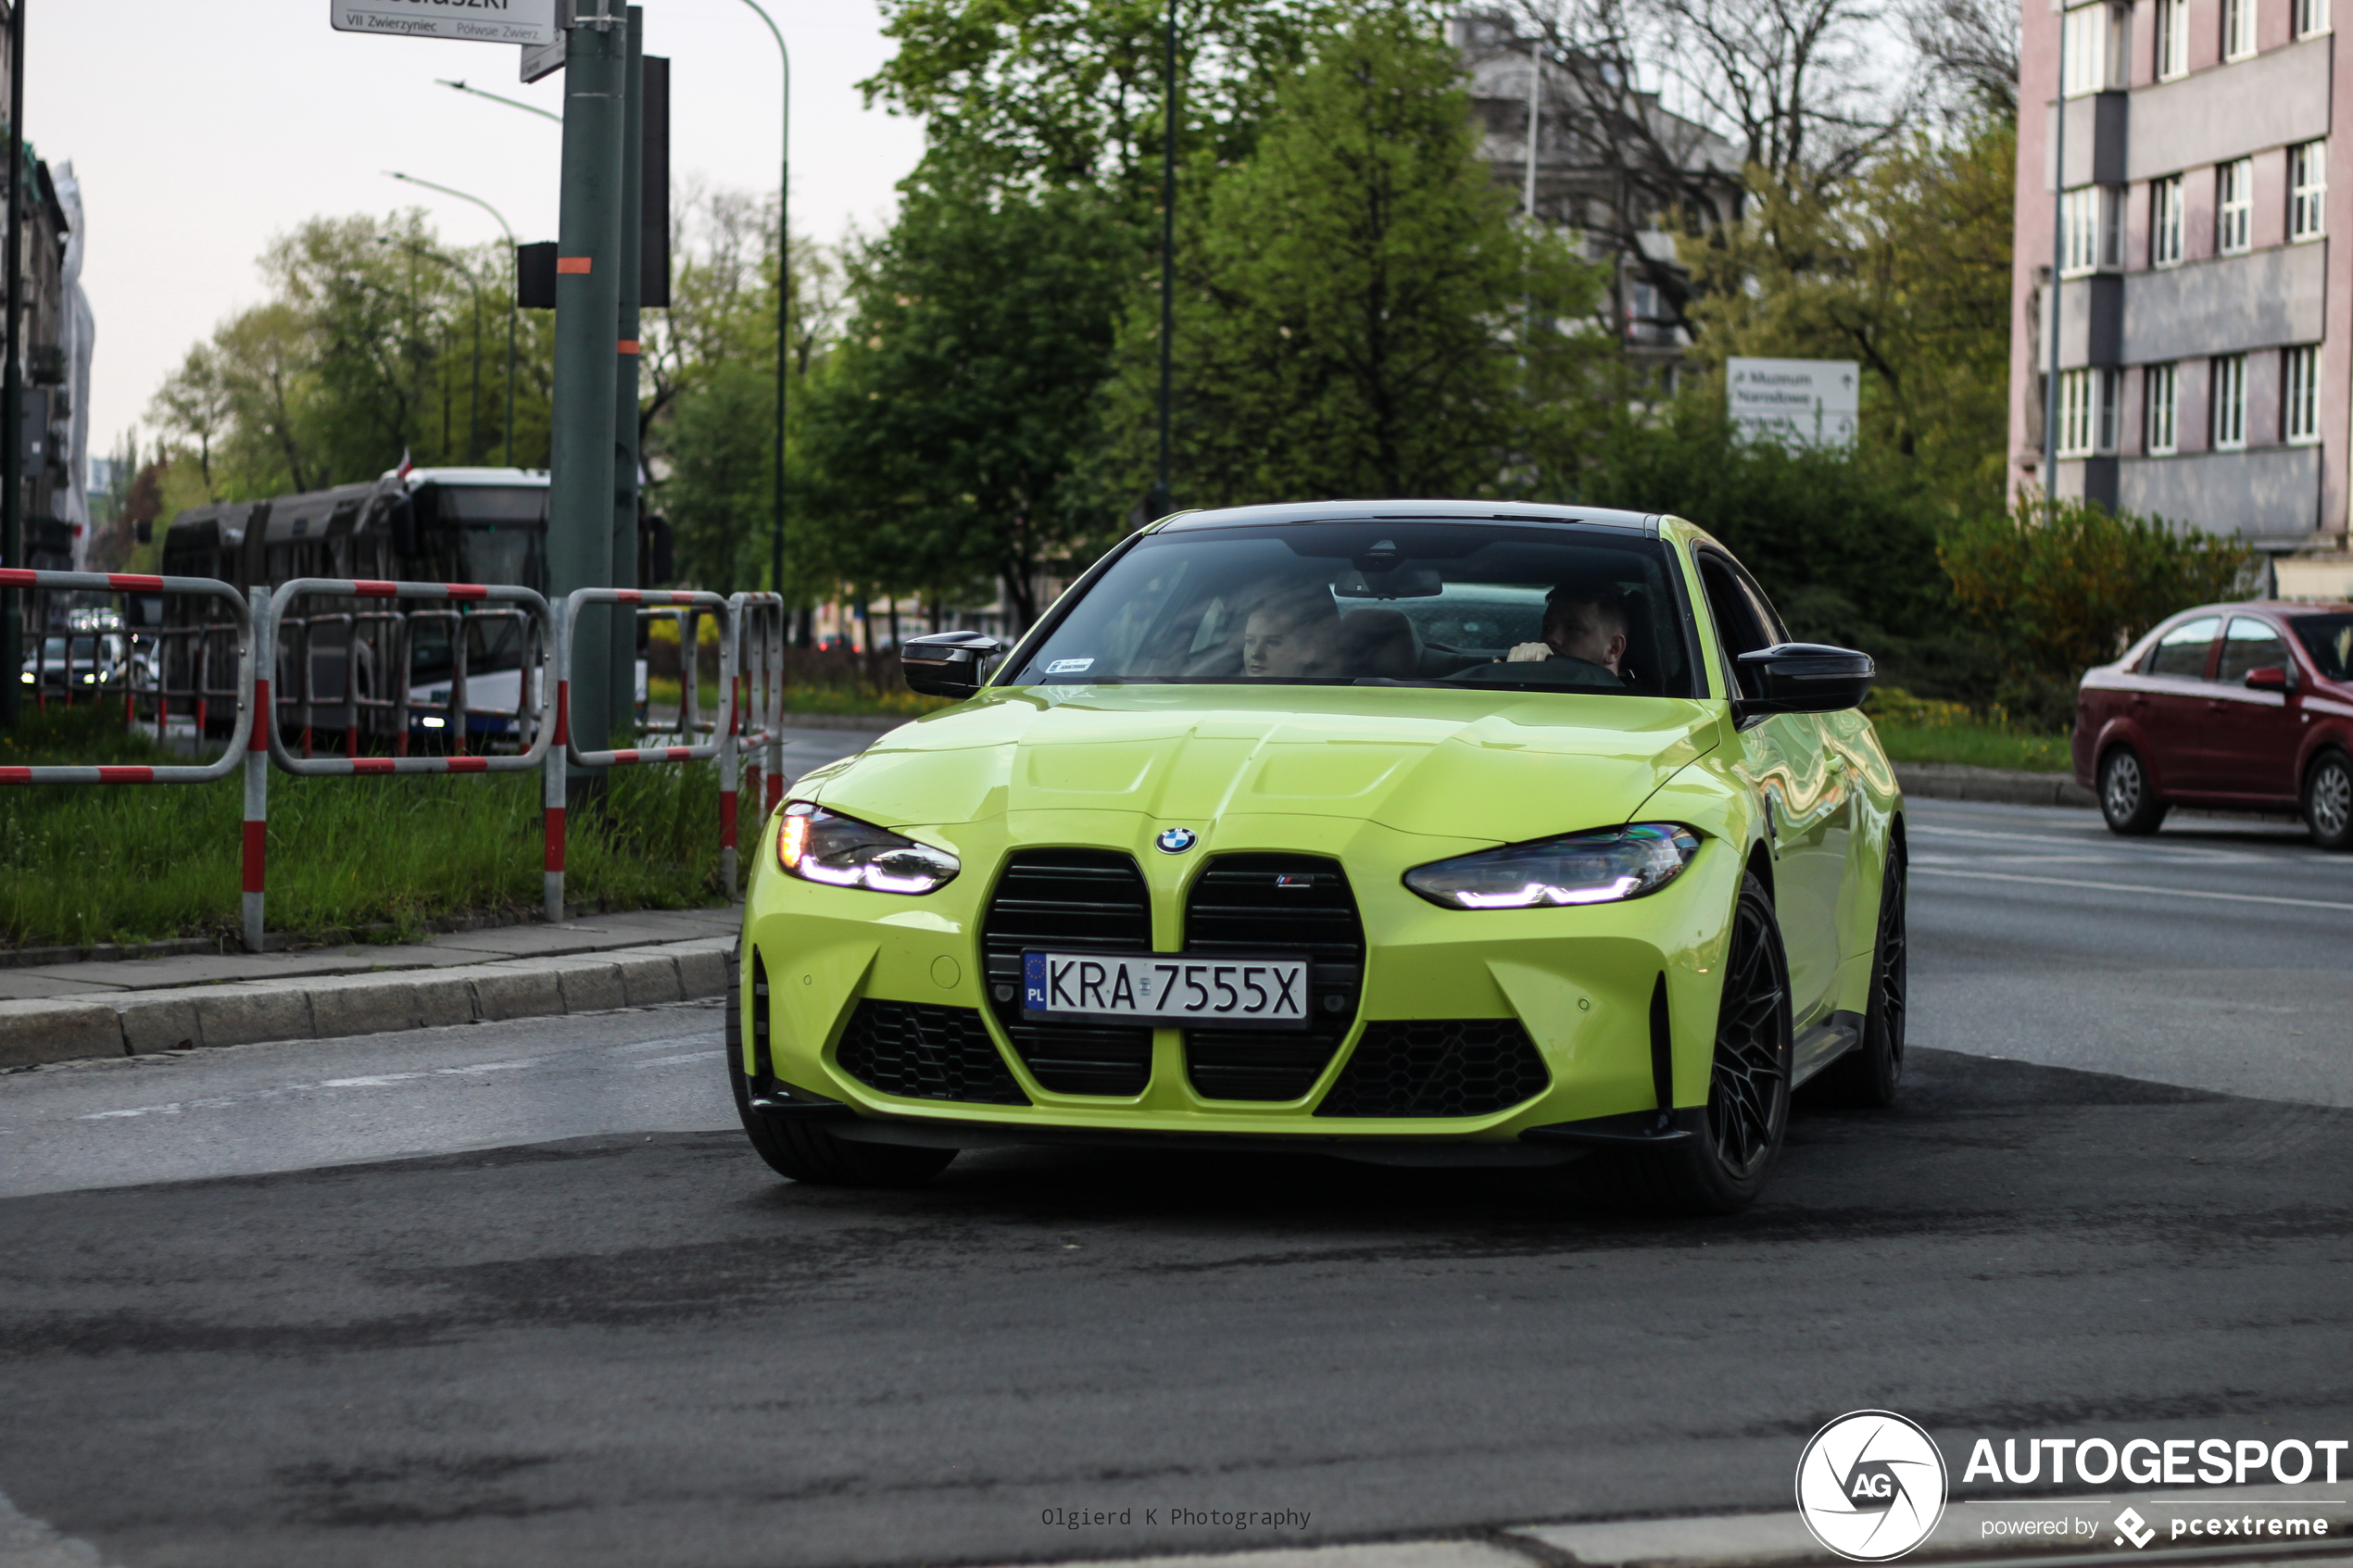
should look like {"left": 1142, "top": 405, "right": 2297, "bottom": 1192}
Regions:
{"left": 548, "top": 0, "right": 628, "bottom": 784}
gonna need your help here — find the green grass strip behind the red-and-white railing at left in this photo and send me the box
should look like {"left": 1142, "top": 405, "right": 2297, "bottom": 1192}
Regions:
{"left": 0, "top": 708, "right": 720, "bottom": 947}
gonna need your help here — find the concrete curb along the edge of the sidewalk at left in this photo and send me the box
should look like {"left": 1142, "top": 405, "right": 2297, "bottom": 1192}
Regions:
{"left": 0, "top": 935, "right": 734, "bottom": 1067}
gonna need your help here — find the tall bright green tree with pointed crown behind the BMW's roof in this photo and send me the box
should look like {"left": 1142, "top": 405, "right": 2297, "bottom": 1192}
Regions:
{"left": 1111, "top": 7, "right": 1604, "bottom": 506}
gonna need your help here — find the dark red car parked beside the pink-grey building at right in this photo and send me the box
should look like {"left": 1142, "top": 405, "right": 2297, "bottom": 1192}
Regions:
{"left": 2075, "top": 599, "right": 2353, "bottom": 848}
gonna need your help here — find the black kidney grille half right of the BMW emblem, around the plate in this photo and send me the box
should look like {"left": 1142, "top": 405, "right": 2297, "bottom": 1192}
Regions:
{"left": 1184, "top": 856, "right": 1365, "bottom": 1100}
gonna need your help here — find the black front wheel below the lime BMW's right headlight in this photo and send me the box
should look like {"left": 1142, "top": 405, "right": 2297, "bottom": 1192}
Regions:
{"left": 1600, "top": 872, "right": 1793, "bottom": 1215}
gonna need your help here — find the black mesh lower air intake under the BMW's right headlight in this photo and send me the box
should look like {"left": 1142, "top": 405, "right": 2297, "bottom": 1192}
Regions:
{"left": 1315, "top": 1018, "right": 1553, "bottom": 1117}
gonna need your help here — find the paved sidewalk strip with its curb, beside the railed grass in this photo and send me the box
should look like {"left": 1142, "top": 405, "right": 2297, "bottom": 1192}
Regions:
{"left": 0, "top": 908, "right": 741, "bottom": 1067}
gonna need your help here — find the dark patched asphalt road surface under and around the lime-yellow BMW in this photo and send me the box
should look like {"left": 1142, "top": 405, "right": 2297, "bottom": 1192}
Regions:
{"left": 0, "top": 802, "right": 2353, "bottom": 1568}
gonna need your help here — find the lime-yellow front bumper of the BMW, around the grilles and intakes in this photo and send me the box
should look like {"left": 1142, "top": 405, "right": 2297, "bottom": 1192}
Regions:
{"left": 741, "top": 811, "right": 1742, "bottom": 1163}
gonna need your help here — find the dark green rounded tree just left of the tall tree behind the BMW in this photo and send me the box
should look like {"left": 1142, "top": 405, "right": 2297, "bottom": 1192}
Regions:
{"left": 805, "top": 169, "right": 1132, "bottom": 625}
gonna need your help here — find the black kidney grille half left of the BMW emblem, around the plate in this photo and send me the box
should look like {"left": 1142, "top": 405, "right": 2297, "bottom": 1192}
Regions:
{"left": 981, "top": 848, "right": 1153, "bottom": 1098}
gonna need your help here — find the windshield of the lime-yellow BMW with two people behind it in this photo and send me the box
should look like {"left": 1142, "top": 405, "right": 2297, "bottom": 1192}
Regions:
{"left": 1005, "top": 520, "right": 1692, "bottom": 696}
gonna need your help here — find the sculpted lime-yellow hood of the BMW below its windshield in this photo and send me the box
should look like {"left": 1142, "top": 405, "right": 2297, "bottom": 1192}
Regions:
{"left": 813, "top": 686, "right": 1722, "bottom": 844}
